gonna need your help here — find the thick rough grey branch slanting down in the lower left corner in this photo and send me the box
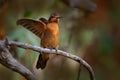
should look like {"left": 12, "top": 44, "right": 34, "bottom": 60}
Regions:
{"left": 0, "top": 41, "right": 37, "bottom": 80}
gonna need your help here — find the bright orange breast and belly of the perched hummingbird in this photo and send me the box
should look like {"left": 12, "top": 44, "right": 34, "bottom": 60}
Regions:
{"left": 41, "top": 24, "right": 59, "bottom": 48}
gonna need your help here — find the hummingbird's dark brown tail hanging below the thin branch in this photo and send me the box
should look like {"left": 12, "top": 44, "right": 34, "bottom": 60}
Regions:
{"left": 36, "top": 54, "right": 49, "bottom": 69}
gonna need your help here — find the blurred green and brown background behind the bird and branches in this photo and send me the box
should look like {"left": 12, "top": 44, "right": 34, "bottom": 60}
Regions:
{"left": 0, "top": 0, "right": 120, "bottom": 80}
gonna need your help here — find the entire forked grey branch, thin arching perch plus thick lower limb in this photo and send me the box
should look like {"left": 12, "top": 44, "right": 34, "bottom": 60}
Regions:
{"left": 0, "top": 40, "right": 95, "bottom": 80}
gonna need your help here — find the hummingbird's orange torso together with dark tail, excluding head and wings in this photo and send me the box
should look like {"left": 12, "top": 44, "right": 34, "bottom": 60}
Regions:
{"left": 36, "top": 18, "right": 59, "bottom": 69}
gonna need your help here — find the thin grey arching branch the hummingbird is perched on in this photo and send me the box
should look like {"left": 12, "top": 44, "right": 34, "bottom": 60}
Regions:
{"left": 8, "top": 41, "right": 95, "bottom": 80}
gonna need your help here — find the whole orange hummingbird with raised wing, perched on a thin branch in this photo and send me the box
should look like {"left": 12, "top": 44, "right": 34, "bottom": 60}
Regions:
{"left": 17, "top": 13, "right": 61, "bottom": 69}
